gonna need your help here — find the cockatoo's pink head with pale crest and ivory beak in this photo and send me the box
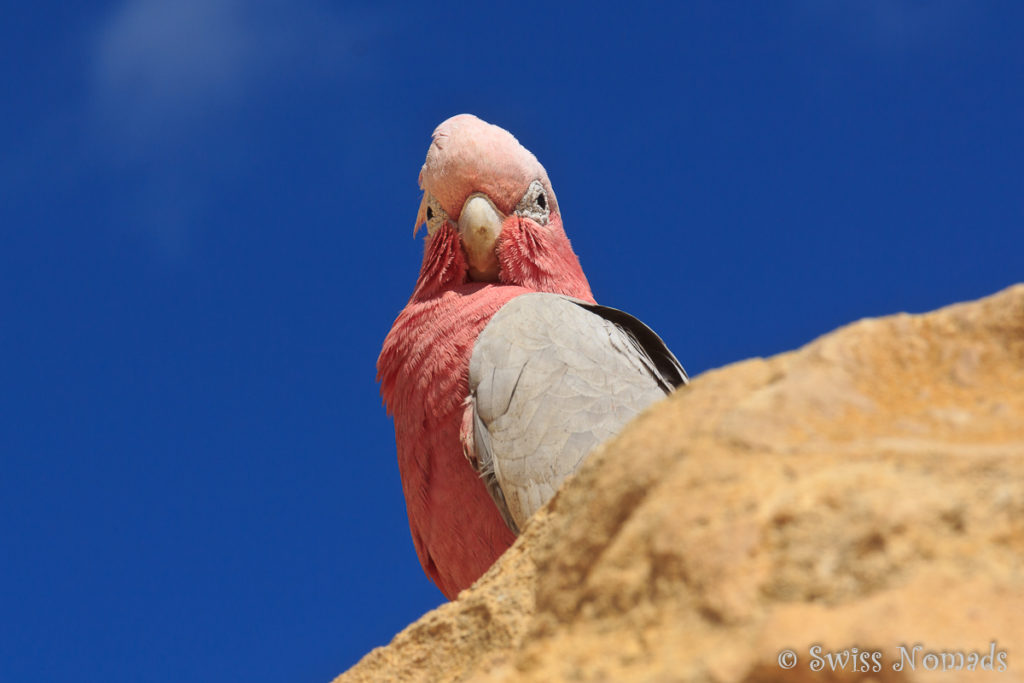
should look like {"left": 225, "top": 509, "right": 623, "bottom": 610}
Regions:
{"left": 414, "top": 114, "right": 591, "bottom": 299}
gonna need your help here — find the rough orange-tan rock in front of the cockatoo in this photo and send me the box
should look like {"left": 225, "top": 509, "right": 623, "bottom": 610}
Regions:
{"left": 336, "top": 285, "right": 1024, "bottom": 683}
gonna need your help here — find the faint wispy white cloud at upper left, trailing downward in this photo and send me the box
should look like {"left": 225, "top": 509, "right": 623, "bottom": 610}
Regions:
{"left": 84, "top": 0, "right": 372, "bottom": 260}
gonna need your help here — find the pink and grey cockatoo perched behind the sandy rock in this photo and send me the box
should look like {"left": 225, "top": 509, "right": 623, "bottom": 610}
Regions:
{"left": 377, "top": 114, "right": 687, "bottom": 599}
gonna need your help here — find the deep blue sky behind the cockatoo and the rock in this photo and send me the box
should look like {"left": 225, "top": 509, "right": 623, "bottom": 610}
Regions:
{"left": 0, "top": 0, "right": 1024, "bottom": 683}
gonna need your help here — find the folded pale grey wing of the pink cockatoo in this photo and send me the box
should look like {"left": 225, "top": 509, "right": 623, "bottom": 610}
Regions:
{"left": 469, "top": 293, "right": 687, "bottom": 532}
